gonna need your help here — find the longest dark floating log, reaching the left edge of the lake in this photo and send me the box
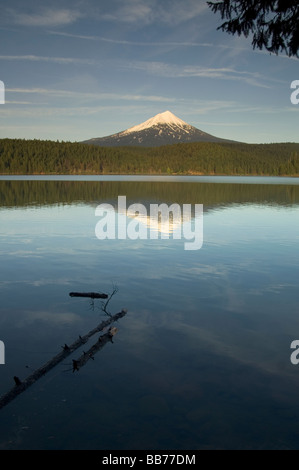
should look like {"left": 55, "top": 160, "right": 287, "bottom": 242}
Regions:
{"left": 0, "top": 309, "right": 127, "bottom": 409}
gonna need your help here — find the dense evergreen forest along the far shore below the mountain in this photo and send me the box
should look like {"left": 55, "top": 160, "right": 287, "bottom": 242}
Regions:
{"left": 0, "top": 139, "right": 299, "bottom": 176}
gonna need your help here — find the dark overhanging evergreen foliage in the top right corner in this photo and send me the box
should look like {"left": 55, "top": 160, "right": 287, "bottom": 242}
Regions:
{"left": 207, "top": 0, "right": 299, "bottom": 57}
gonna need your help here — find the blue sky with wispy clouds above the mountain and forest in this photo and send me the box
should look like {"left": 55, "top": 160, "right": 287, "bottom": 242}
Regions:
{"left": 0, "top": 0, "right": 299, "bottom": 143}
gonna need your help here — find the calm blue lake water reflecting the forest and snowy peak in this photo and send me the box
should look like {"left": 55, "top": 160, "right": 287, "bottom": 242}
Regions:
{"left": 0, "top": 176, "right": 299, "bottom": 450}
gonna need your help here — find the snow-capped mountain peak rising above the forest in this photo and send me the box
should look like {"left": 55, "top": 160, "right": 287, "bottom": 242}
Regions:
{"left": 83, "top": 111, "right": 239, "bottom": 147}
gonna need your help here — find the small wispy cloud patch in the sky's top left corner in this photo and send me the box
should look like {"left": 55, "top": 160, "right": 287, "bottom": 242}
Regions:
{"left": 8, "top": 8, "right": 83, "bottom": 27}
